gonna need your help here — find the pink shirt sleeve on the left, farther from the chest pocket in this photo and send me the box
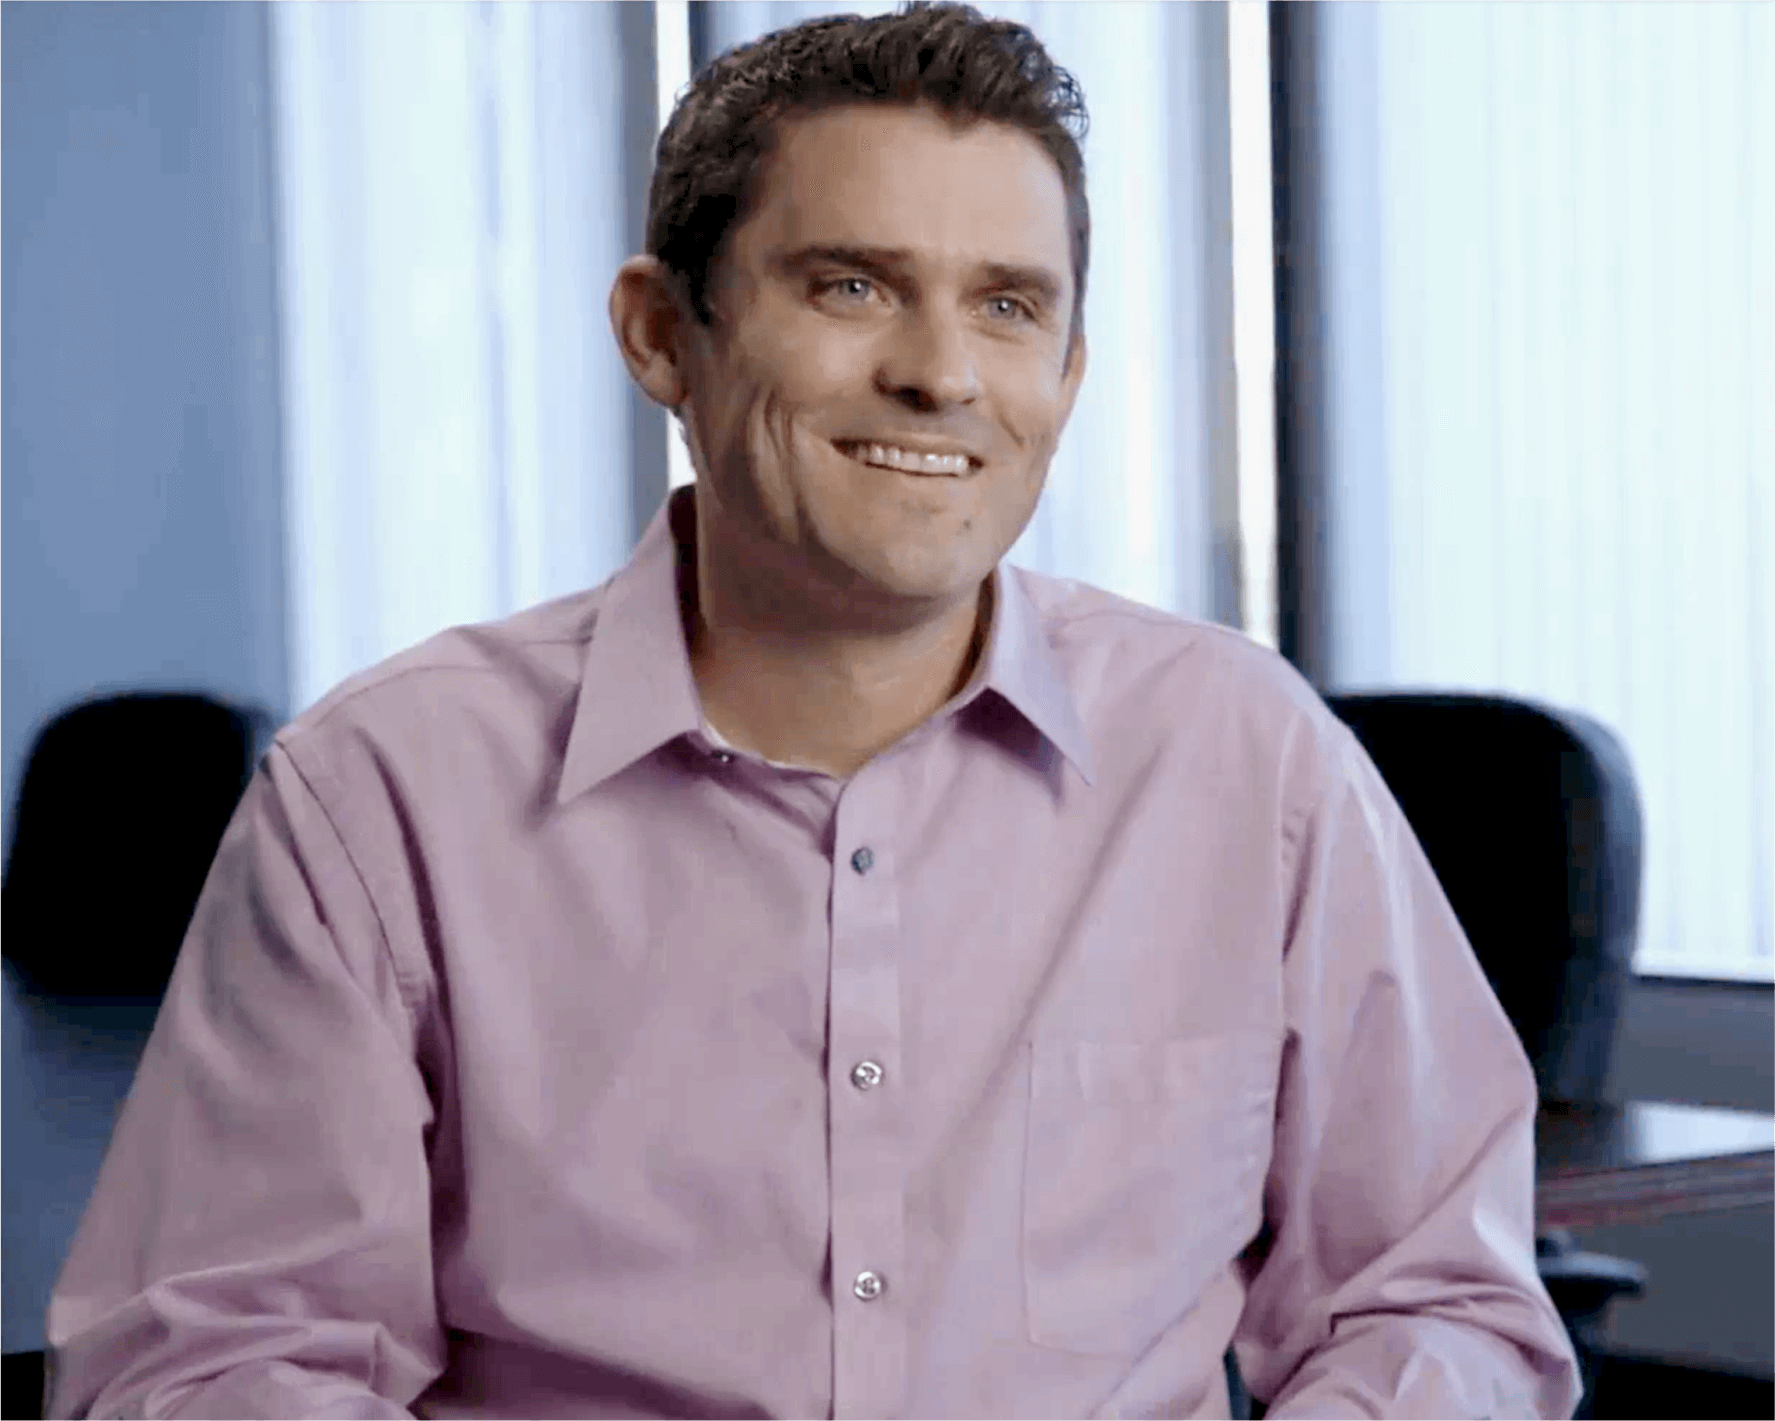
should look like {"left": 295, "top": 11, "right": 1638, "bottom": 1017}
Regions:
{"left": 46, "top": 747, "right": 444, "bottom": 1421}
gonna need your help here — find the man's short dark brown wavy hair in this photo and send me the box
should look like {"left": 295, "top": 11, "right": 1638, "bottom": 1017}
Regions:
{"left": 646, "top": 0, "right": 1092, "bottom": 360}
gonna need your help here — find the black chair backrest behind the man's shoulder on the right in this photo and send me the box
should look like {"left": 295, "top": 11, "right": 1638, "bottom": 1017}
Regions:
{"left": 1326, "top": 692, "right": 1642, "bottom": 1100}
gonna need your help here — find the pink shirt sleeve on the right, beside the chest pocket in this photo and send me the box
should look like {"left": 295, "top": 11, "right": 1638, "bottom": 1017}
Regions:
{"left": 1235, "top": 731, "right": 1580, "bottom": 1421}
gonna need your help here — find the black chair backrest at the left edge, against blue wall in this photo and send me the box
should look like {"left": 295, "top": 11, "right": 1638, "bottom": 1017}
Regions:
{"left": 0, "top": 692, "right": 275, "bottom": 997}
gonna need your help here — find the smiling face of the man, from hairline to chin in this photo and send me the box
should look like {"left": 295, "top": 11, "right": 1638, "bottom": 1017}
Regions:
{"left": 683, "top": 106, "right": 1085, "bottom": 619}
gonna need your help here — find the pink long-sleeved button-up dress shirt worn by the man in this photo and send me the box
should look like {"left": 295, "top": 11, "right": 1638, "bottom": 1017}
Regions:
{"left": 48, "top": 490, "right": 1578, "bottom": 1421}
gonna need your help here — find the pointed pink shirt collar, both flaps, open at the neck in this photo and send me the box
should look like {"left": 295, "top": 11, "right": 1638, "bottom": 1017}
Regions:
{"left": 556, "top": 484, "right": 1095, "bottom": 804}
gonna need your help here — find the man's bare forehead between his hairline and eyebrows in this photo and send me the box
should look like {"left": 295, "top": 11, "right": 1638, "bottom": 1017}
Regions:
{"left": 735, "top": 105, "right": 1070, "bottom": 286}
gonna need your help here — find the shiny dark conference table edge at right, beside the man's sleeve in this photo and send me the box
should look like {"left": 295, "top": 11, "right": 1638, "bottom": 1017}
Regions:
{"left": 1535, "top": 1100, "right": 1775, "bottom": 1233}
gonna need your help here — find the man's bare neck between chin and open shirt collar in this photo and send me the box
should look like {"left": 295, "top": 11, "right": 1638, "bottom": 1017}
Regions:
{"left": 685, "top": 549, "right": 992, "bottom": 779}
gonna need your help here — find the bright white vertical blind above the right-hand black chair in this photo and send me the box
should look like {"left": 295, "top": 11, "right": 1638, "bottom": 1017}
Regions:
{"left": 1333, "top": 4, "right": 1775, "bottom": 981}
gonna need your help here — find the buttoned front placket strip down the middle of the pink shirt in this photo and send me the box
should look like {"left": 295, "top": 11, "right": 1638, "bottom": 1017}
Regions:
{"left": 827, "top": 781, "right": 907, "bottom": 1421}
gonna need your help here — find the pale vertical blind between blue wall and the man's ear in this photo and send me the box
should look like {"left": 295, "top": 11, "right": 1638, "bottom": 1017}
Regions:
{"left": 272, "top": 0, "right": 666, "bottom": 711}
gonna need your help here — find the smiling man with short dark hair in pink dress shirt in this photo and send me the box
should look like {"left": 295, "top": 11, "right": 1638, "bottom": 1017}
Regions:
{"left": 48, "top": 5, "right": 1576, "bottom": 1421}
